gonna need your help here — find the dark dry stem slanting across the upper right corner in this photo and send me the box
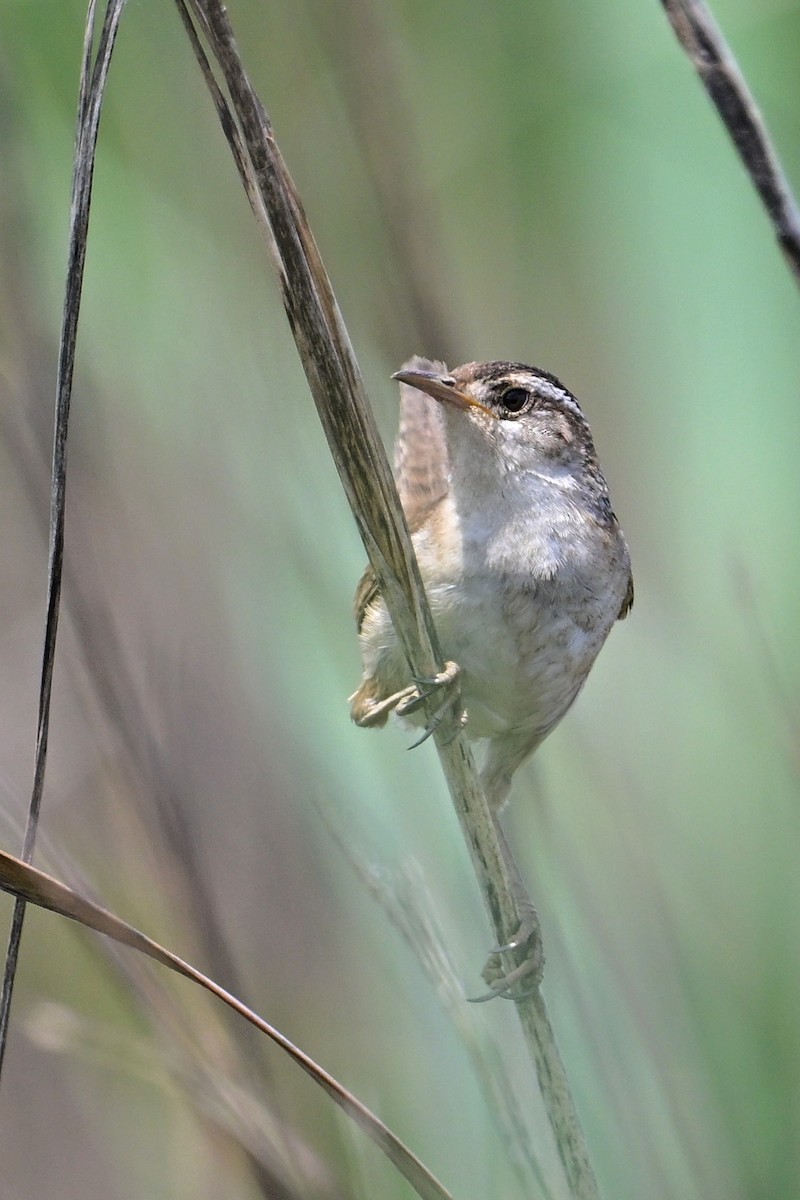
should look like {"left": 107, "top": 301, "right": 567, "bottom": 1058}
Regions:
{"left": 661, "top": 0, "right": 800, "bottom": 283}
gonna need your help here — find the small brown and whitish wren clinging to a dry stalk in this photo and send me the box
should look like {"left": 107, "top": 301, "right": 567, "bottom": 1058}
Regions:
{"left": 349, "top": 356, "right": 633, "bottom": 993}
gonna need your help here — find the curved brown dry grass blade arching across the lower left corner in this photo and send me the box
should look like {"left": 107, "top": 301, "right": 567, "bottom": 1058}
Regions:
{"left": 0, "top": 851, "right": 451, "bottom": 1200}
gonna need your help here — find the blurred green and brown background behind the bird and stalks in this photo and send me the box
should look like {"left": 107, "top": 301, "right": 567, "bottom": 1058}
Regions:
{"left": 0, "top": 0, "right": 800, "bottom": 1200}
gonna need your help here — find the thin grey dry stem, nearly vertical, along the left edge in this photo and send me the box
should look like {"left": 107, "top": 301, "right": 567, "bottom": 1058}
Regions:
{"left": 0, "top": 0, "right": 125, "bottom": 1089}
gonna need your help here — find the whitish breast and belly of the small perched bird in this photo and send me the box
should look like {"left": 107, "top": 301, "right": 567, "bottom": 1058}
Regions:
{"left": 414, "top": 488, "right": 627, "bottom": 738}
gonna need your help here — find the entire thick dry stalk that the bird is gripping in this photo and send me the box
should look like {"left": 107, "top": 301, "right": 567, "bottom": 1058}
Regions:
{"left": 176, "top": 0, "right": 599, "bottom": 1200}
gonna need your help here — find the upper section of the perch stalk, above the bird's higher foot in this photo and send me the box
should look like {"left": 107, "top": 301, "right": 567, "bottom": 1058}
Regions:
{"left": 178, "top": 0, "right": 443, "bottom": 676}
